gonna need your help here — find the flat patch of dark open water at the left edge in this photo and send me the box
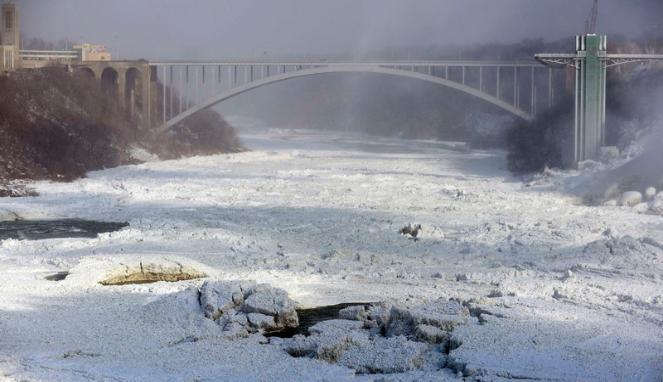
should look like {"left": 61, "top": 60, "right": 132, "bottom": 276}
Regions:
{"left": 0, "top": 219, "right": 129, "bottom": 240}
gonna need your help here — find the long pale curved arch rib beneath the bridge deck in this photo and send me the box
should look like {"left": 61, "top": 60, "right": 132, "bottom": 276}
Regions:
{"left": 159, "top": 64, "right": 532, "bottom": 133}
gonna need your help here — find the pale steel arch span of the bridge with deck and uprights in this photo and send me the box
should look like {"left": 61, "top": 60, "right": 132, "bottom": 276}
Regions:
{"left": 149, "top": 60, "right": 559, "bottom": 131}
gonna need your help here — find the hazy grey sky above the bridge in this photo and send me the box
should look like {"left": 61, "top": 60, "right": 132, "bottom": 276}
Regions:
{"left": 15, "top": 0, "right": 663, "bottom": 59}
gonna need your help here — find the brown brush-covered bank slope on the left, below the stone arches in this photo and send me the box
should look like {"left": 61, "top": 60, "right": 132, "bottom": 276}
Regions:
{"left": 0, "top": 67, "right": 240, "bottom": 181}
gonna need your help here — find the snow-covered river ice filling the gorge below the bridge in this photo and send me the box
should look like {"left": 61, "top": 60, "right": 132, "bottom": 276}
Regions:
{"left": 0, "top": 131, "right": 663, "bottom": 381}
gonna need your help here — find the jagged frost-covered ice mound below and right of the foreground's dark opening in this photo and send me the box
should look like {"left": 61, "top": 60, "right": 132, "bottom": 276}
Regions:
{"left": 272, "top": 300, "right": 469, "bottom": 374}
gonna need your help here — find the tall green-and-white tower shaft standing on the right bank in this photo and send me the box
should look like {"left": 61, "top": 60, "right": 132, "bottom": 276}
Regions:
{"left": 573, "top": 35, "right": 607, "bottom": 164}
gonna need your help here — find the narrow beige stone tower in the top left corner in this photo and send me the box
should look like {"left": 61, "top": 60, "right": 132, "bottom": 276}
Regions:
{"left": 0, "top": 3, "right": 21, "bottom": 72}
